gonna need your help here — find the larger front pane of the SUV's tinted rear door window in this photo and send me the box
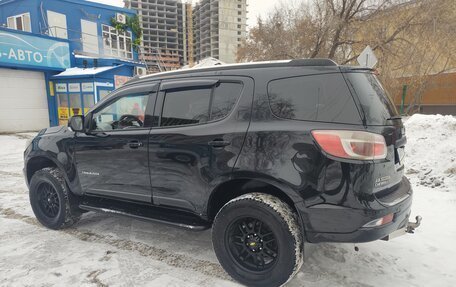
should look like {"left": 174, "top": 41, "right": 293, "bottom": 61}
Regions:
{"left": 161, "top": 88, "right": 212, "bottom": 126}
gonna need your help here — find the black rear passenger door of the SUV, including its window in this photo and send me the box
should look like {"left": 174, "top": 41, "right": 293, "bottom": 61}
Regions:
{"left": 149, "top": 76, "right": 253, "bottom": 213}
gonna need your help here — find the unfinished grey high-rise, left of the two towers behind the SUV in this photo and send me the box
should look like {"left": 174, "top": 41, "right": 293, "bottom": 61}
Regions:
{"left": 125, "top": 0, "right": 183, "bottom": 71}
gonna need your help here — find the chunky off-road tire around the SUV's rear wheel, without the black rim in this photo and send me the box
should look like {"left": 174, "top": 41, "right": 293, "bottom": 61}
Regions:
{"left": 212, "top": 193, "right": 303, "bottom": 286}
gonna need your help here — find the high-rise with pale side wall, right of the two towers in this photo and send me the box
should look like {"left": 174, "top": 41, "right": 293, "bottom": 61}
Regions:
{"left": 193, "top": 0, "right": 247, "bottom": 63}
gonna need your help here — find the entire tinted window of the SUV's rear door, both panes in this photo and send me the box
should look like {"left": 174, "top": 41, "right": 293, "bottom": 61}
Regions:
{"left": 161, "top": 82, "right": 243, "bottom": 127}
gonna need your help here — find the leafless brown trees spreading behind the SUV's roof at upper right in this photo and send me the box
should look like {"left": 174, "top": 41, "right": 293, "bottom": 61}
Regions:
{"left": 238, "top": 0, "right": 456, "bottom": 115}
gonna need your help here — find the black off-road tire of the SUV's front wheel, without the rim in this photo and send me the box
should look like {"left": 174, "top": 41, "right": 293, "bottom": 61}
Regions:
{"left": 29, "top": 167, "right": 82, "bottom": 230}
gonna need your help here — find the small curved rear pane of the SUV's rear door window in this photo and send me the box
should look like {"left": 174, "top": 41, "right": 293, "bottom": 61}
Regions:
{"left": 211, "top": 83, "right": 243, "bottom": 120}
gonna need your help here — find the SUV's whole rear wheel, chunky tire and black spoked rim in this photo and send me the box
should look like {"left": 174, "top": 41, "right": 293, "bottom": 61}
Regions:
{"left": 212, "top": 193, "right": 303, "bottom": 286}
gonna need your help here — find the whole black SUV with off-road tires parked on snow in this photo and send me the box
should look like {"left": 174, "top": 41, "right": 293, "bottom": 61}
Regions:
{"left": 24, "top": 59, "right": 412, "bottom": 286}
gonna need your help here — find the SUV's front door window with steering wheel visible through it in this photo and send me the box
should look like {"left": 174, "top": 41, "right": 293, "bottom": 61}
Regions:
{"left": 91, "top": 94, "right": 149, "bottom": 131}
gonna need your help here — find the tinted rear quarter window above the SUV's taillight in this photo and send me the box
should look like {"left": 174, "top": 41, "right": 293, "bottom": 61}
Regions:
{"left": 268, "top": 73, "right": 362, "bottom": 124}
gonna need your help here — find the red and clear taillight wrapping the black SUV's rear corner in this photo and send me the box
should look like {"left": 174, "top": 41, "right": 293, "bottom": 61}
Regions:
{"left": 312, "top": 130, "right": 387, "bottom": 160}
